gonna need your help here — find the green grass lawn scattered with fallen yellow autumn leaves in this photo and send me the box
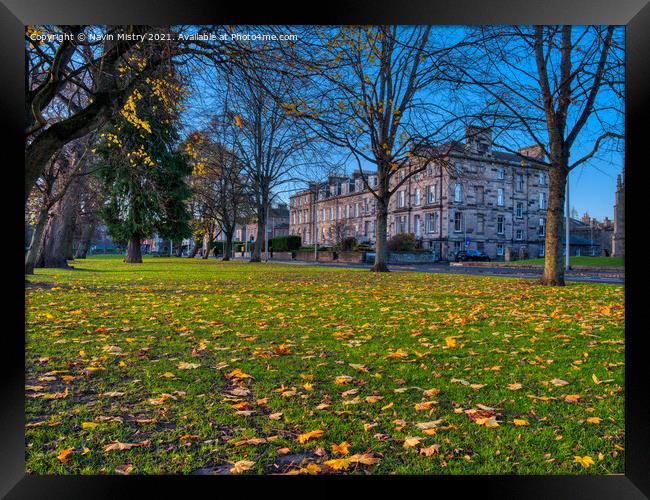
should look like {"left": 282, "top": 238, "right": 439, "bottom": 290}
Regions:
{"left": 25, "top": 257, "right": 625, "bottom": 474}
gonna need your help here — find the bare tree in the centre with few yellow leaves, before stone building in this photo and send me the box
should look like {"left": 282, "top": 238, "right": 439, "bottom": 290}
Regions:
{"left": 285, "top": 26, "right": 464, "bottom": 272}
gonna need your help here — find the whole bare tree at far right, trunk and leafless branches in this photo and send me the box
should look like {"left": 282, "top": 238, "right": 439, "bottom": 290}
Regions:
{"left": 464, "top": 25, "right": 624, "bottom": 285}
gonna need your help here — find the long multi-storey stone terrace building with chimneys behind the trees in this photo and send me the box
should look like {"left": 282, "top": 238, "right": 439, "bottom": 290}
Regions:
{"left": 289, "top": 127, "right": 548, "bottom": 260}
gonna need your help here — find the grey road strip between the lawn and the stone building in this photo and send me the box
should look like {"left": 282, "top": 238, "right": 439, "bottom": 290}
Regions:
{"left": 229, "top": 257, "right": 625, "bottom": 285}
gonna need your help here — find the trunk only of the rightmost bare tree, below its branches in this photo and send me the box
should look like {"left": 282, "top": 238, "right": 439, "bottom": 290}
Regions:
{"left": 541, "top": 162, "right": 567, "bottom": 286}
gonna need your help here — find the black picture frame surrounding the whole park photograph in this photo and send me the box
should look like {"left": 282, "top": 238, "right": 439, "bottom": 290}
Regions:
{"left": 0, "top": 0, "right": 650, "bottom": 500}
